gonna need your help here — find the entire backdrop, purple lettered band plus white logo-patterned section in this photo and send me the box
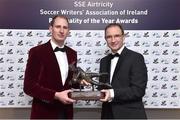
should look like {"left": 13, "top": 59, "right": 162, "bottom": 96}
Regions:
{"left": 0, "top": 0, "right": 180, "bottom": 108}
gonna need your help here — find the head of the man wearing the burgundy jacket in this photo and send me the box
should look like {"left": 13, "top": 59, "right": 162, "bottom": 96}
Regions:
{"left": 49, "top": 17, "right": 69, "bottom": 45}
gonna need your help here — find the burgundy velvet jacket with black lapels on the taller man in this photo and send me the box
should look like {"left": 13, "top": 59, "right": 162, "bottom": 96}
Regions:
{"left": 24, "top": 41, "right": 77, "bottom": 119}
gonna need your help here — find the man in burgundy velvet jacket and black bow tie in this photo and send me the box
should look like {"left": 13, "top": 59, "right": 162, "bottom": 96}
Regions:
{"left": 24, "top": 16, "right": 87, "bottom": 119}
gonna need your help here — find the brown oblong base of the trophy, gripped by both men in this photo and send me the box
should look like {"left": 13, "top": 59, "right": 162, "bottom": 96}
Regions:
{"left": 69, "top": 91, "right": 105, "bottom": 100}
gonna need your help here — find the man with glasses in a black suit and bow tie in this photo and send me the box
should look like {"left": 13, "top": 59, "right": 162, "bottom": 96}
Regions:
{"left": 100, "top": 23, "right": 147, "bottom": 119}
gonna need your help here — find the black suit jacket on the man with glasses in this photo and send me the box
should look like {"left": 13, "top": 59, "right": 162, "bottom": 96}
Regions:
{"left": 100, "top": 47, "right": 147, "bottom": 119}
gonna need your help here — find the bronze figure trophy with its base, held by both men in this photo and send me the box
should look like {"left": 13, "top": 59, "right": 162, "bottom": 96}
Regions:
{"left": 69, "top": 65, "right": 112, "bottom": 100}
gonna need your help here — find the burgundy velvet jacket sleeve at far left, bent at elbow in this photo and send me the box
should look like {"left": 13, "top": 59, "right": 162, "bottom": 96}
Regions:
{"left": 24, "top": 49, "right": 55, "bottom": 102}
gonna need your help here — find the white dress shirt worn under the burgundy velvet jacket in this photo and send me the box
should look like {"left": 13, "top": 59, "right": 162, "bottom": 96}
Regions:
{"left": 50, "top": 40, "right": 69, "bottom": 85}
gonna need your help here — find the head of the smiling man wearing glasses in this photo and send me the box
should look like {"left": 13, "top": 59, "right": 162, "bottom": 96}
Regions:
{"left": 105, "top": 26, "right": 124, "bottom": 53}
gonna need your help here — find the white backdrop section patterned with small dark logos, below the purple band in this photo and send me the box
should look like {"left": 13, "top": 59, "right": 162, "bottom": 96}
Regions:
{"left": 0, "top": 29, "right": 180, "bottom": 108}
